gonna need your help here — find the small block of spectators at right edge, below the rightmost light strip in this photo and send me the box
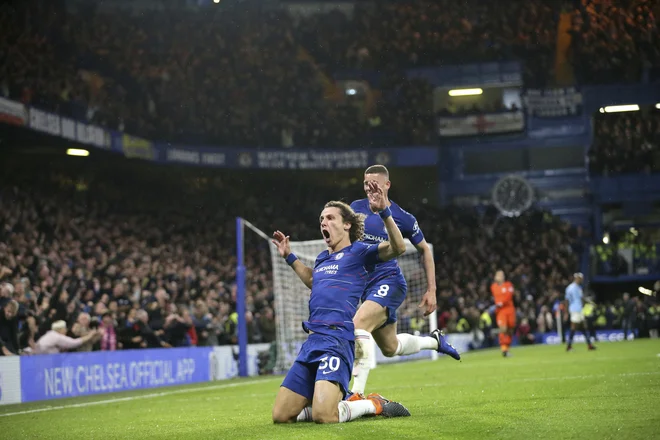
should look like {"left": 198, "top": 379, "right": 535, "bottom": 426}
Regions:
{"left": 589, "top": 110, "right": 660, "bottom": 176}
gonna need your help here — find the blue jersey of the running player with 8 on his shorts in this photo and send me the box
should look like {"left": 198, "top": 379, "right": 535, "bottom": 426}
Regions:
{"left": 351, "top": 199, "right": 424, "bottom": 286}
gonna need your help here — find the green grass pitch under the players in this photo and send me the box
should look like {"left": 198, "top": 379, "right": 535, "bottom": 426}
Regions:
{"left": 0, "top": 340, "right": 660, "bottom": 440}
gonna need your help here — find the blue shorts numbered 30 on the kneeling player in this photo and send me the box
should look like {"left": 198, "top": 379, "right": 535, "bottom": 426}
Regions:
{"left": 282, "top": 333, "right": 355, "bottom": 402}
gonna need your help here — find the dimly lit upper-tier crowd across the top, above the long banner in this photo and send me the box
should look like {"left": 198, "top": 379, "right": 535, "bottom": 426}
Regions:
{"left": 0, "top": 0, "right": 660, "bottom": 147}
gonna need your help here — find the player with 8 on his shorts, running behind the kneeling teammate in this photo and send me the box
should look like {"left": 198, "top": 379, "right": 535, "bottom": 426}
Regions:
{"left": 350, "top": 165, "right": 461, "bottom": 400}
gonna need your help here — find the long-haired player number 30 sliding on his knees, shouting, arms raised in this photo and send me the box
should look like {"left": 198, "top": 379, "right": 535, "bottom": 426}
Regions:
{"left": 273, "top": 183, "right": 410, "bottom": 423}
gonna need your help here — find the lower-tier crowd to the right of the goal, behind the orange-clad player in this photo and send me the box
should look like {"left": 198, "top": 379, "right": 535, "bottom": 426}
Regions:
{"left": 392, "top": 206, "right": 660, "bottom": 346}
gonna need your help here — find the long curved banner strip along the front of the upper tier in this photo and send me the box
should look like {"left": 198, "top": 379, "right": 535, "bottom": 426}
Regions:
{"left": 0, "top": 99, "right": 440, "bottom": 170}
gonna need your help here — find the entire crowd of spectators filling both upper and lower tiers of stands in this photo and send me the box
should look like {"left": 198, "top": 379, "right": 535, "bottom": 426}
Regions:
{"left": 0, "top": 0, "right": 660, "bottom": 360}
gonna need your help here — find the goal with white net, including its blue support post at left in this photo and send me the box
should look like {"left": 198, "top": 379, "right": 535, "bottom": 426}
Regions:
{"left": 236, "top": 217, "right": 438, "bottom": 376}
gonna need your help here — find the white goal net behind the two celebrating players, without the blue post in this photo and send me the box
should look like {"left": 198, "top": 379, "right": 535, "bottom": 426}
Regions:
{"left": 270, "top": 235, "right": 437, "bottom": 372}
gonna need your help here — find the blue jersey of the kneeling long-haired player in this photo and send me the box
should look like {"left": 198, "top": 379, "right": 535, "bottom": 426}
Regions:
{"left": 303, "top": 242, "right": 380, "bottom": 341}
